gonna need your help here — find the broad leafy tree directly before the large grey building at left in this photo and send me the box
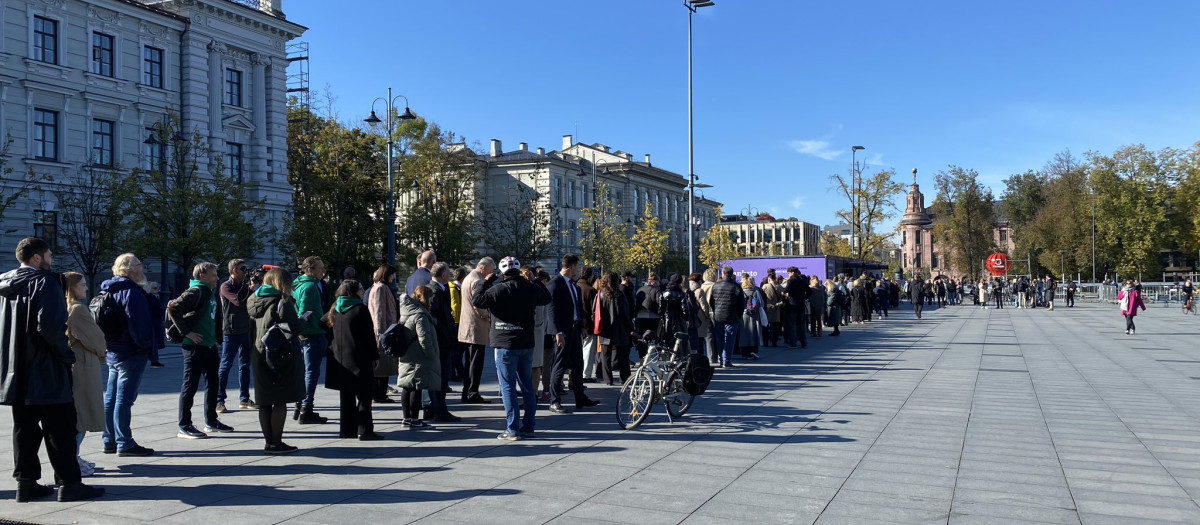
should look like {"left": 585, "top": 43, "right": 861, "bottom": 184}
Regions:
{"left": 113, "top": 116, "right": 267, "bottom": 289}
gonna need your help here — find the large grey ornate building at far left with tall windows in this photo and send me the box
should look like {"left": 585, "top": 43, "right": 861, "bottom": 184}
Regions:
{"left": 0, "top": 0, "right": 306, "bottom": 280}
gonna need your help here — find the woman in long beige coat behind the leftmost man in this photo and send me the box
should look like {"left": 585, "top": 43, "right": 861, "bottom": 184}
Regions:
{"left": 62, "top": 272, "right": 107, "bottom": 476}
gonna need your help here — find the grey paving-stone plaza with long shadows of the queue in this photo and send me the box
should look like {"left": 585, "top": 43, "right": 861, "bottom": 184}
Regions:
{"left": 0, "top": 299, "right": 1200, "bottom": 525}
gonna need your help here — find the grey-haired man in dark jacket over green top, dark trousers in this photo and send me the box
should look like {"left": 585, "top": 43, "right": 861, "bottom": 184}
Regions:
{"left": 167, "top": 263, "right": 233, "bottom": 440}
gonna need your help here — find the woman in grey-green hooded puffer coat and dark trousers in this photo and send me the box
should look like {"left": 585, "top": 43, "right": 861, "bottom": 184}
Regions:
{"left": 396, "top": 286, "right": 443, "bottom": 428}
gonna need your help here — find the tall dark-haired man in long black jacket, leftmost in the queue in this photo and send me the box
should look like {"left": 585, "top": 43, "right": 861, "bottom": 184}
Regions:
{"left": 0, "top": 237, "right": 104, "bottom": 502}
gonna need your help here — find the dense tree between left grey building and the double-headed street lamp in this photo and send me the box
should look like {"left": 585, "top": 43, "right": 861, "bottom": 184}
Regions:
{"left": 286, "top": 108, "right": 388, "bottom": 276}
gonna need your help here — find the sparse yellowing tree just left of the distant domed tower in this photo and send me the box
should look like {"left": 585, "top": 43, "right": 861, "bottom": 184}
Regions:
{"left": 832, "top": 168, "right": 904, "bottom": 260}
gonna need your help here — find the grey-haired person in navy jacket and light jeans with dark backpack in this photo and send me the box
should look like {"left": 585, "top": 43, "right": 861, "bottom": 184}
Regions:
{"left": 99, "top": 253, "right": 163, "bottom": 457}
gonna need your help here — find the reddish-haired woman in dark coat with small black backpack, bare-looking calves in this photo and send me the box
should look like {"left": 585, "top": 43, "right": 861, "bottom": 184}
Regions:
{"left": 246, "top": 267, "right": 305, "bottom": 454}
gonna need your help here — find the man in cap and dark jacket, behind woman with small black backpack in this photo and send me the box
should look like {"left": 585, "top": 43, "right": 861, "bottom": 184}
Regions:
{"left": 217, "top": 259, "right": 255, "bottom": 414}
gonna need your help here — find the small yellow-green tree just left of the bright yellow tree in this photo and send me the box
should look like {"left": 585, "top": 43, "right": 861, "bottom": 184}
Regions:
{"left": 580, "top": 182, "right": 635, "bottom": 272}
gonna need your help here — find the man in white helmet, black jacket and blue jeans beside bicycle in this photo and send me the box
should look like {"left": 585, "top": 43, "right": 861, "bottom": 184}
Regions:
{"left": 470, "top": 257, "right": 551, "bottom": 441}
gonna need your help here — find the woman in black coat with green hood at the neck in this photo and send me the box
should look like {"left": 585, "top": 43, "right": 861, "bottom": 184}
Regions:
{"left": 324, "top": 280, "right": 383, "bottom": 441}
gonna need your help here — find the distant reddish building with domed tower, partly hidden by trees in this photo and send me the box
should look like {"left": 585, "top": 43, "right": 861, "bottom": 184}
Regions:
{"left": 900, "top": 169, "right": 1016, "bottom": 277}
